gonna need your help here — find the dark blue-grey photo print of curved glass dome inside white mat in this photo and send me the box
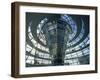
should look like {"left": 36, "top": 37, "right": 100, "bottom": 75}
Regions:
{"left": 25, "top": 13, "right": 90, "bottom": 67}
